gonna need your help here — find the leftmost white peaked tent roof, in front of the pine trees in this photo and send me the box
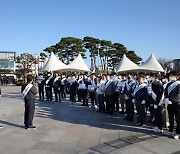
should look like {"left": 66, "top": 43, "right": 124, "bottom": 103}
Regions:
{"left": 41, "top": 52, "right": 69, "bottom": 71}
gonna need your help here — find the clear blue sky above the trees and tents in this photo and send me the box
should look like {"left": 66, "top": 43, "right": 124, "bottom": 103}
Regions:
{"left": 0, "top": 0, "right": 180, "bottom": 65}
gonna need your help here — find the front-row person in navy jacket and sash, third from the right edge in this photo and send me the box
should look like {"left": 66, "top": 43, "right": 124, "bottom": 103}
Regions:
{"left": 133, "top": 74, "right": 148, "bottom": 127}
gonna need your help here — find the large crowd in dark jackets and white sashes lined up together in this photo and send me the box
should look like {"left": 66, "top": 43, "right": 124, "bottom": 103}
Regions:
{"left": 34, "top": 72, "right": 180, "bottom": 139}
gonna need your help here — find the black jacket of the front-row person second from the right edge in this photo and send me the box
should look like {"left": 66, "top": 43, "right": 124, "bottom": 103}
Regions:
{"left": 152, "top": 82, "right": 164, "bottom": 105}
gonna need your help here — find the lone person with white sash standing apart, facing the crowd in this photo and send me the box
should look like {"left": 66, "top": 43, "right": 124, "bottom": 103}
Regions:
{"left": 21, "top": 75, "right": 38, "bottom": 129}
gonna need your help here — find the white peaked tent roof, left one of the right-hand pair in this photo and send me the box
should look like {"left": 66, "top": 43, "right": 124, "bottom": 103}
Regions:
{"left": 116, "top": 54, "right": 142, "bottom": 72}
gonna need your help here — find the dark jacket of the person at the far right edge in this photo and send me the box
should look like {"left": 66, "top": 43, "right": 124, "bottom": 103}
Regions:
{"left": 165, "top": 81, "right": 180, "bottom": 103}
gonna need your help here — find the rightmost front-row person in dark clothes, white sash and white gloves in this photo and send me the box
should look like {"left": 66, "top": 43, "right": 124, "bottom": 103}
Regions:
{"left": 165, "top": 72, "right": 180, "bottom": 139}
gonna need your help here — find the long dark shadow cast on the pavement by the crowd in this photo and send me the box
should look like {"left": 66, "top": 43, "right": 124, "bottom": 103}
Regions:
{"left": 35, "top": 101, "right": 155, "bottom": 134}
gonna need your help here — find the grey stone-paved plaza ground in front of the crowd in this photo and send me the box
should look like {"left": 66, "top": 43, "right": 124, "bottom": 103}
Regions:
{"left": 0, "top": 86, "right": 180, "bottom": 154}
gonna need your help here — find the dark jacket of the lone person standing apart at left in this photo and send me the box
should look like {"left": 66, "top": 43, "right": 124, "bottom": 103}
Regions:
{"left": 21, "top": 83, "right": 38, "bottom": 100}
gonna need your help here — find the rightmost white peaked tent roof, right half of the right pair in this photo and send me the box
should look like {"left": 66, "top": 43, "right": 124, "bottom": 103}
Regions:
{"left": 140, "top": 54, "right": 164, "bottom": 72}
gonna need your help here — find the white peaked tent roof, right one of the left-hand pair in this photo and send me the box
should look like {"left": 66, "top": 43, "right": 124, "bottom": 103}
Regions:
{"left": 68, "top": 54, "right": 90, "bottom": 72}
